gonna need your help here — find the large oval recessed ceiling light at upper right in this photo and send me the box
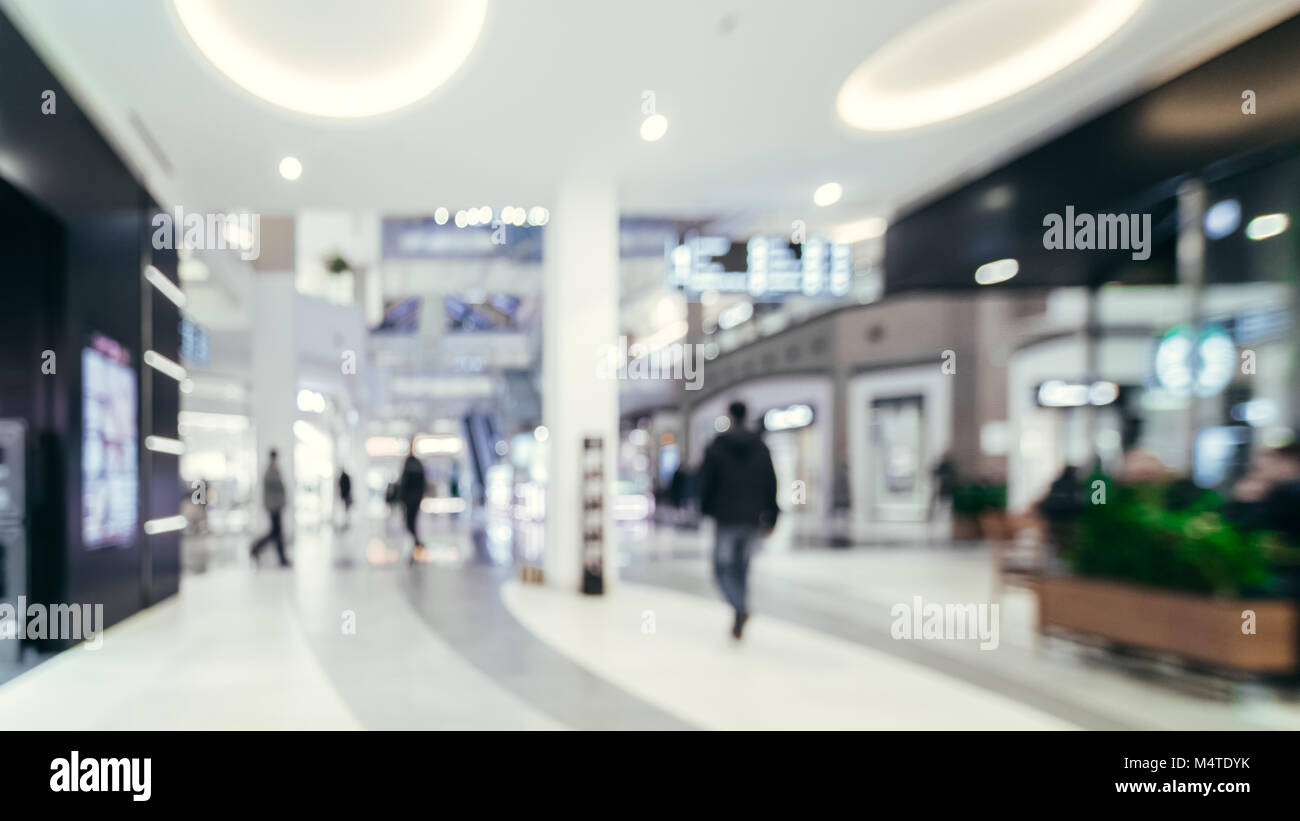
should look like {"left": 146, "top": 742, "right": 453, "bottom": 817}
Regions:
{"left": 836, "top": 0, "right": 1141, "bottom": 131}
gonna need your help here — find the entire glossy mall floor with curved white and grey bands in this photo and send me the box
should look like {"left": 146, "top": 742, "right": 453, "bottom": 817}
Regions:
{"left": 0, "top": 517, "right": 1300, "bottom": 729}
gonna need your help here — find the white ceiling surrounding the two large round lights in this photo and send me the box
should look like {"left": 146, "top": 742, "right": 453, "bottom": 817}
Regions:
{"left": 0, "top": 0, "right": 1300, "bottom": 220}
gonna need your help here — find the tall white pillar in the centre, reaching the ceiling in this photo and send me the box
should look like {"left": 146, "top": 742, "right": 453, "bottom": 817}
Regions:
{"left": 542, "top": 173, "right": 619, "bottom": 591}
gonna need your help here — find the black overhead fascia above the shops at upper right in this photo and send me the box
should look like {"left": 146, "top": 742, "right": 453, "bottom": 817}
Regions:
{"left": 884, "top": 17, "right": 1300, "bottom": 294}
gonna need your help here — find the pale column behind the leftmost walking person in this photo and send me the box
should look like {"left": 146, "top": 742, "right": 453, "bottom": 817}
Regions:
{"left": 250, "top": 272, "right": 298, "bottom": 533}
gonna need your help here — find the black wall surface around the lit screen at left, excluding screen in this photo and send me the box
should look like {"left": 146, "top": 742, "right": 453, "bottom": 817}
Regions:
{"left": 0, "top": 8, "right": 179, "bottom": 633}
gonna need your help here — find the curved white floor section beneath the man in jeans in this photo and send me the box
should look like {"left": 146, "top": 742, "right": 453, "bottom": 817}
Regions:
{"left": 503, "top": 582, "right": 1071, "bottom": 730}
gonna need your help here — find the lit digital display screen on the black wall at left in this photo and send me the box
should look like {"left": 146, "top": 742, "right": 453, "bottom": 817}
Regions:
{"left": 82, "top": 336, "right": 139, "bottom": 549}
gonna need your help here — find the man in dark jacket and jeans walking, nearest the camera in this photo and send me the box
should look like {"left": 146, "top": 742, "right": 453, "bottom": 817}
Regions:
{"left": 699, "top": 401, "right": 781, "bottom": 639}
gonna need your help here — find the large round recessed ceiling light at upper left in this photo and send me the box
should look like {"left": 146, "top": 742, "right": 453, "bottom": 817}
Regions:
{"left": 173, "top": 0, "right": 488, "bottom": 117}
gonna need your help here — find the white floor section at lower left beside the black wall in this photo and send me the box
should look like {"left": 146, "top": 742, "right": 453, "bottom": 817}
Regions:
{"left": 0, "top": 573, "right": 361, "bottom": 730}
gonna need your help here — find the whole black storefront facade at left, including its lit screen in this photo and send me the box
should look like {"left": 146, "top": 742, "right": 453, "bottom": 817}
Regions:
{"left": 0, "top": 16, "right": 182, "bottom": 654}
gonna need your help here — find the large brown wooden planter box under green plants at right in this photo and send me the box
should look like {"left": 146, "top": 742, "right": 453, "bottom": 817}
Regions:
{"left": 1037, "top": 577, "right": 1300, "bottom": 673}
